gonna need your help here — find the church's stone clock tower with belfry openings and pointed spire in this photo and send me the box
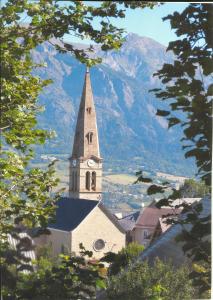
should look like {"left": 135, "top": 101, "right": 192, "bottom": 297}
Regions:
{"left": 69, "top": 68, "right": 102, "bottom": 200}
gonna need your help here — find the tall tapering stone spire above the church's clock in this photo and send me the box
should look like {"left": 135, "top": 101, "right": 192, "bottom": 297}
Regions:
{"left": 71, "top": 68, "right": 100, "bottom": 158}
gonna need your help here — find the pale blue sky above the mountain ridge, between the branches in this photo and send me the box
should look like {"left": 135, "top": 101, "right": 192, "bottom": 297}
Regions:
{"left": 65, "top": 1, "right": 188, "bottom": 46}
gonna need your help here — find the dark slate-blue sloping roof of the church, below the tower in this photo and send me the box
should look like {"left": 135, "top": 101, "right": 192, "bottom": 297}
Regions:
{"left": 48, "top": 198, "right": 99, "bottom": 231}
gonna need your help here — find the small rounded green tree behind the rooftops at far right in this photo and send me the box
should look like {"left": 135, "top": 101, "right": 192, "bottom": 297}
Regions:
{"left": 180, "top": 179, "right": 210, "bottom": 198}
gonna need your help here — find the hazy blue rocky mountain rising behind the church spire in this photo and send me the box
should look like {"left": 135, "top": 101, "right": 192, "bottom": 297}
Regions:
{"left": 33, "top": 34, "right": 194, "bottom": 175}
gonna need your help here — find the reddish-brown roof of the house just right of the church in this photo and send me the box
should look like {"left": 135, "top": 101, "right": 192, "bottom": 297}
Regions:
{"left": 135, "top": 207, "right": 181, "bottom": 227}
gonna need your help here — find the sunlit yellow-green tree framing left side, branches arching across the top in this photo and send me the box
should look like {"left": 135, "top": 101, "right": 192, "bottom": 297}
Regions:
{"left": 0, "top": 0, "right": 154, "bottom": 297}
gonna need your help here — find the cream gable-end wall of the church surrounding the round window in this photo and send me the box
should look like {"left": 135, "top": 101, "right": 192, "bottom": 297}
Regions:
{"left": 72, "top": 207, "right": 126, "bottom": 258}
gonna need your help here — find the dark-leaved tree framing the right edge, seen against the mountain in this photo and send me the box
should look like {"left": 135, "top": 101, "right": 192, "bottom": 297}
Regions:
{"left": 138, "top": 3, "right": 213, "bottom": 294}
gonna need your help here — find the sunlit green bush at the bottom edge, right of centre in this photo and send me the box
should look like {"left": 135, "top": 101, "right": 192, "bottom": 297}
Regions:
{"left": 107, "top": 259, "right": 194, "bottom": 300}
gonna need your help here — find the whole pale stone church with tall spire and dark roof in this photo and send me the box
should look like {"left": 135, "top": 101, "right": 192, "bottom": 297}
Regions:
{"left": 39, "top": 68, "right": 126, "bottom": 258}
